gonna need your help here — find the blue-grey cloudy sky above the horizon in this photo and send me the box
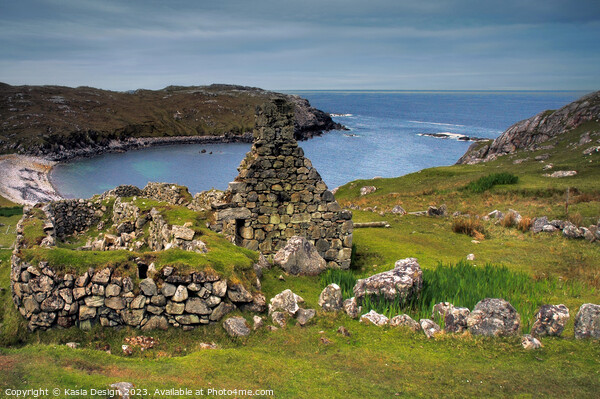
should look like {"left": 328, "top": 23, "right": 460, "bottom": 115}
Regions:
{"left": 0, "top": 0, "right": 600, "bottom": 91}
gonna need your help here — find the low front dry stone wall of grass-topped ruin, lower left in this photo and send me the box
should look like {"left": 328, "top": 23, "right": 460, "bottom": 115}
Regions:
{"left": 11, "top": 254, "right": 258, "bottom": 331}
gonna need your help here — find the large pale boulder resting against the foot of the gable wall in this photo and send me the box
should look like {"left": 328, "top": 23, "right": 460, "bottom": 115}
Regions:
{"left": 273, "top": 236, "right": 329, "bottom": 276}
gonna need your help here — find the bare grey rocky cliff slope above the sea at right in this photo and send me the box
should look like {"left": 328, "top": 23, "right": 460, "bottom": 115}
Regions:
{"left": 457, "top": 91, "right": 600, "bottom": 164}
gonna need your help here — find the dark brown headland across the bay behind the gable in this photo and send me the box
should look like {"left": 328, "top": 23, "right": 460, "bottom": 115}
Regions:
{"left": 0, "top": 83, "right": 342, "bottom": 160}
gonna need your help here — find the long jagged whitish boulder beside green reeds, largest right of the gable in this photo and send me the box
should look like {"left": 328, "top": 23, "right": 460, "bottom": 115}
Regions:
{"left": 354, "top": 258, "right": 423, "bottom": 303}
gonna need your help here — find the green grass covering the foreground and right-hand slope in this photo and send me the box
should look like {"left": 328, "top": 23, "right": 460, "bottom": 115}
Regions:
{"left": 0, "top": 118, "right": 600, "bottom": 398}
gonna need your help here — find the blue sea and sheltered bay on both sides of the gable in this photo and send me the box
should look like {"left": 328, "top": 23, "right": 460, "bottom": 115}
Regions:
{"left": 50, "top": 91, "right": 585, "bottom": 198}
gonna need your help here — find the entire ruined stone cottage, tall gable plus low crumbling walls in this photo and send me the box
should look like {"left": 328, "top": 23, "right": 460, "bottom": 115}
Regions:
{"left": 11, "top": 100, "right": 353, "bottom": 330}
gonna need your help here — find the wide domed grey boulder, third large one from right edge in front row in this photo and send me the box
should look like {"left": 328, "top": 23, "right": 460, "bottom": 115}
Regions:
{"left": 467, "top": 298, "right": 521, "bottom": 337}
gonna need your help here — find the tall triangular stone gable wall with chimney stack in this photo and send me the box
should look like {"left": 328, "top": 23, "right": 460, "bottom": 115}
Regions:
{"left": 211, "top": 100, "right": 353, "bottom": 269}
